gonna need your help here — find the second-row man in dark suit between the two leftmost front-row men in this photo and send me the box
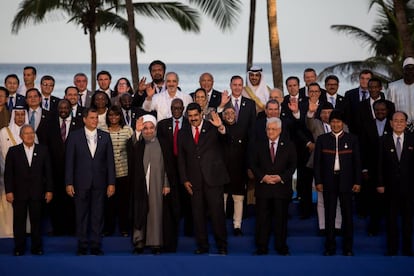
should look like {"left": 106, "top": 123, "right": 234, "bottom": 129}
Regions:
{"left": 48, "top": 99, "right": 83, "bottom": 235}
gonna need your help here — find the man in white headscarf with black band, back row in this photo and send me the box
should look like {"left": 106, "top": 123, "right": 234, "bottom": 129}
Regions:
{"left": 242, "top": 66, "right": 270, "bottom": 114}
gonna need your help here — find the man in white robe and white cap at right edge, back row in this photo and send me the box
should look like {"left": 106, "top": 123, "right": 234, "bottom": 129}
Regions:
{"left": 386, "top": 57, "right": 414, "bottom": 132}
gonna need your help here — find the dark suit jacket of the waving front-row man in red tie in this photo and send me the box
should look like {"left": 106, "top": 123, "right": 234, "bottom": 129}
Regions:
{"left": 178, "top": 120, "right": 229, "bottom": 190}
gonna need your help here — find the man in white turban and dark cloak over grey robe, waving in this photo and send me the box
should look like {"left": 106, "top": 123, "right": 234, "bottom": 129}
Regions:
{"left": 128, "top": 115, "right": 178, "bottom": 255}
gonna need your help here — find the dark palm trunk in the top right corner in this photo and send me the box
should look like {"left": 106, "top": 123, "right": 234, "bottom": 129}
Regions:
{"left": 394, "top": 0, "right": 414, "bottom": 58}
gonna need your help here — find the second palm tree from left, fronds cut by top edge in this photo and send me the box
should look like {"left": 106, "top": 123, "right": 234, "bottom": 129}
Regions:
{"left": 123, "top": 0, "right": 241, "bottom": 89}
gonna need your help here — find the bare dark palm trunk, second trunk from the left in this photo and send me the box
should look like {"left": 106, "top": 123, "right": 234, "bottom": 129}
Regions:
{"left": 125, "top": 0, "right": 139, "bottom": 91}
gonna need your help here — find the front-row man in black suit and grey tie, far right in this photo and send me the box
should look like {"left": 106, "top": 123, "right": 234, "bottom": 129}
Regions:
{"left": 377, "top": 111, "right": 414, "bottom": 256}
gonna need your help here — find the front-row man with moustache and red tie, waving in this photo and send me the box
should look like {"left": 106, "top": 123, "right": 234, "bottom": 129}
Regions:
{"left": 178, "top": 103, "right": 229, "bottom": 255}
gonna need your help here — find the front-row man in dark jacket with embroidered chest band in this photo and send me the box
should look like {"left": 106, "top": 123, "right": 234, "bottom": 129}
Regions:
{"left": 313, "top": 110, "right": 361, "bottom": 256}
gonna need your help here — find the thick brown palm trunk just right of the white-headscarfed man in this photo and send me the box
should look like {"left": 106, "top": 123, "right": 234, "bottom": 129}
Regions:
{"left": 267, "top": 0, "right": 283, "bottom": 91}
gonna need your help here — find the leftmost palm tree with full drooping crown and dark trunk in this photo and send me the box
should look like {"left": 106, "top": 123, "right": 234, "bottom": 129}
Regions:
{"left": 12, "top": 0, "right": 199, "bottom": 90}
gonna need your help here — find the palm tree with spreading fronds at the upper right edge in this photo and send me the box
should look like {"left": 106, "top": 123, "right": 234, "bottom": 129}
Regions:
{"left": 319, "top": 0, "right": 414, "bottom": 82}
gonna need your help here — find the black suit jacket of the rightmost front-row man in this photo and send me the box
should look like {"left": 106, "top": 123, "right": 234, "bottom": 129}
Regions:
{"left": 378, "top": 132, "right": 414, "bottom": 200}
